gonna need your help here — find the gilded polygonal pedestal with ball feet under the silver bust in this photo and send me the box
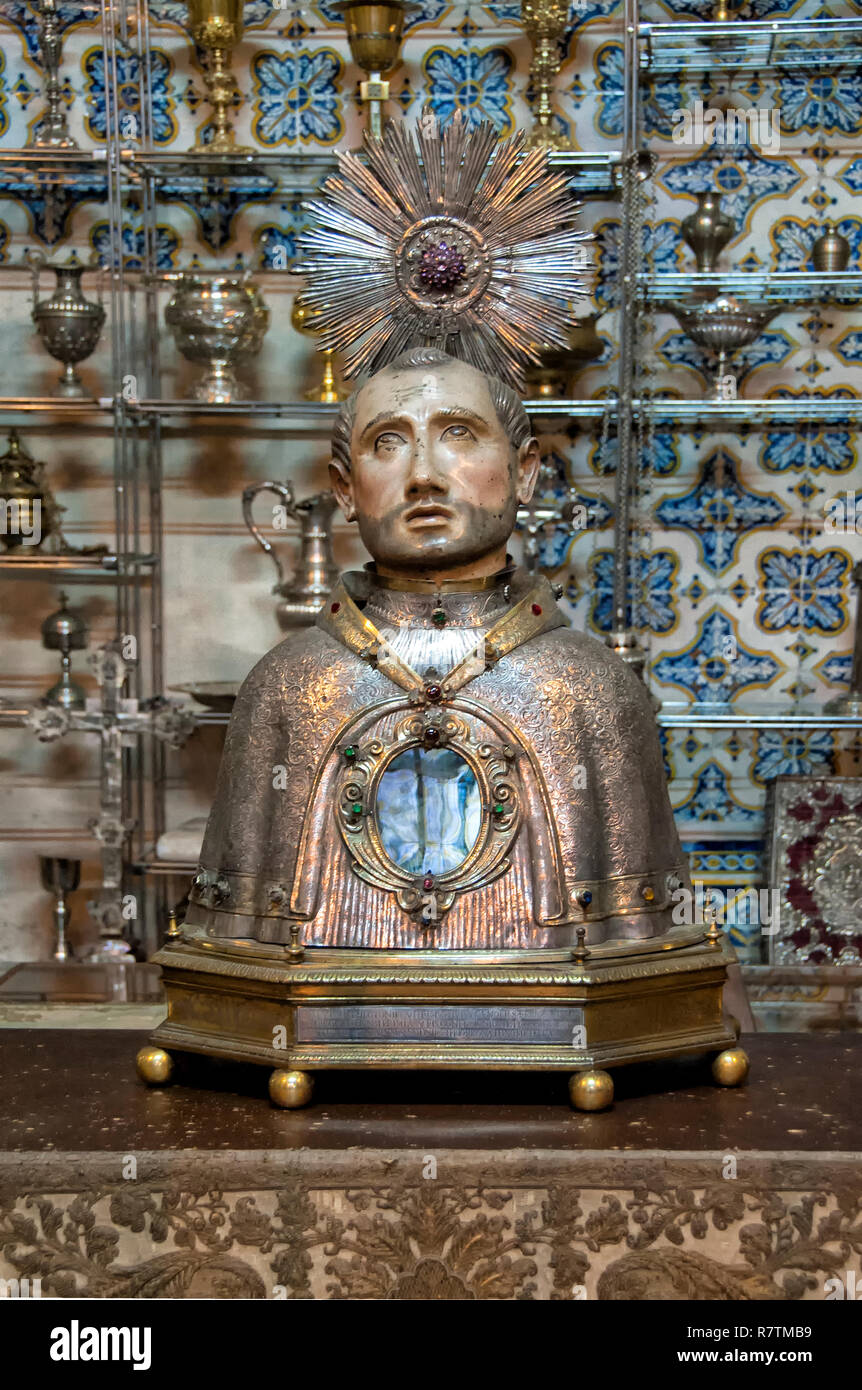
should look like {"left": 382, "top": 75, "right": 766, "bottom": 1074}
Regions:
{"left": 138, "top": 929, "right": 748, "bottom": 1111}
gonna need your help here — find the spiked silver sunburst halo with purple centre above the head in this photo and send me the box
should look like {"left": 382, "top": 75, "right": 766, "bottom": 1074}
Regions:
{"left": 298, "top": 110, "right": 591, "bottom": 389}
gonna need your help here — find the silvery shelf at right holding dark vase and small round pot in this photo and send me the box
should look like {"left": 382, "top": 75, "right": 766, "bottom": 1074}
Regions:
{"left": 638, "top": 270, "right": 862, "bottom": 307}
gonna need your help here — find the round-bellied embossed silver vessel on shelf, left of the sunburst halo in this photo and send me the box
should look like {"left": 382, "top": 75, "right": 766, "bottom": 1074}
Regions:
{"left": 161, "top": 270, "right": 270, "bottom": 404}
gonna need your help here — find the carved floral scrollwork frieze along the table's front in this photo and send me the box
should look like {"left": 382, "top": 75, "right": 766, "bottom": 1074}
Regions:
{"left": 0, "top": 1152, "right": 862, "bottom": 1301}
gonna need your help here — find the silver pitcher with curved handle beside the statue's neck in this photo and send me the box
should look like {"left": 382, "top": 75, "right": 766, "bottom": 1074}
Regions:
{"left": 242, "top": 482, "right": 338, "bottom": 631}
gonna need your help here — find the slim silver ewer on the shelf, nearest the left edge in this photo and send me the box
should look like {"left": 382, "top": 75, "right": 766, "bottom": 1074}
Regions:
{"left": 25, "top": 249, "right": 104, "bottom": 398}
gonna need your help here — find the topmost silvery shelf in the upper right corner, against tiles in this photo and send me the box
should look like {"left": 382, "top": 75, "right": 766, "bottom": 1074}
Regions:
{"left": 638, "top": 18, "right": 862, "bottom": 74}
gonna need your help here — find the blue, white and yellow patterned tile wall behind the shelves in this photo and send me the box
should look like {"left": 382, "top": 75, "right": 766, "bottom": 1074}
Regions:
{"left": 0, "top": 0, "right": 862, "bottom": 958}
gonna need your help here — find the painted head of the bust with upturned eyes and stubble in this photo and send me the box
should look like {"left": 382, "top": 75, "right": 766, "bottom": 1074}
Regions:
{"left": 330, "top": 348, "right": 539, "bottom": 580}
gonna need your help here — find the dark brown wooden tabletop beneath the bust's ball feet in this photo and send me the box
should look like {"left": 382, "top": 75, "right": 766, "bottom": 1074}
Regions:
{"left": 0, "top": 1029, "right": 862, "bottom": 1154}
